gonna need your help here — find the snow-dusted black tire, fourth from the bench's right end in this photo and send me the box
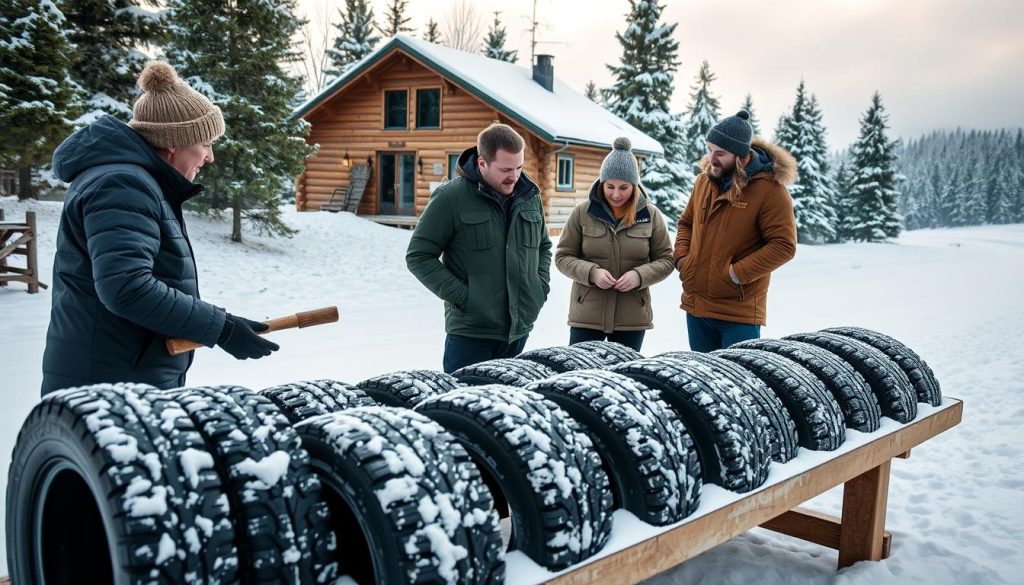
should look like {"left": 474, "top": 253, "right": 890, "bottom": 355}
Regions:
{"left": 713, "top": 349, "right": 846, "bottom": 451}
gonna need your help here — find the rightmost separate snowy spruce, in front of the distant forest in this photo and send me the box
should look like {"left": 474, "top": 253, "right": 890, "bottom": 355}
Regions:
{"left": 844, "top": 91, "right": 902, "bottom": 242}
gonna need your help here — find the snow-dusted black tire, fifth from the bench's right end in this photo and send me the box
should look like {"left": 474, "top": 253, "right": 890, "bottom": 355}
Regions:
{"left": 657, "top": 351, "right": 800, "bottom": 463}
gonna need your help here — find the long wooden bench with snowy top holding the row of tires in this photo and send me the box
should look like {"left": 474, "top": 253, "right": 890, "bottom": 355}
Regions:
{"left": 506, "top": 398, "right": 964, "bottom": 585}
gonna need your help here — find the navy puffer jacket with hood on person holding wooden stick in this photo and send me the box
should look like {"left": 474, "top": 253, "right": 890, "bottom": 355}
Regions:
{"left": 42, "top": 116, "right": 224, "bottom": 394}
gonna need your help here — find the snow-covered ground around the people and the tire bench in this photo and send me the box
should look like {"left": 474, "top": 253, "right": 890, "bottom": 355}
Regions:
{"left": 0, "top": 198, "right": 1024, "bottom": 585}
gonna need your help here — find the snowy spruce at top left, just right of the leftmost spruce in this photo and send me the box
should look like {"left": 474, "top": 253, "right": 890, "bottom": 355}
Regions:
{"left": 61, "top": 0, "right": 162, "bottom": 124}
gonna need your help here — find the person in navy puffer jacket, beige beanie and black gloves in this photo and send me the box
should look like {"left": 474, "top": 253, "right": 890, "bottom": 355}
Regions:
{"left": 42, "top": 61, "right": 278, "bottom": 394}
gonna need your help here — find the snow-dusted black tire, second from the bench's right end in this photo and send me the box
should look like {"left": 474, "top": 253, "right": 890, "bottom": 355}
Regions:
{"left": 783, "top": 332, "right": 918, "bottom": 423}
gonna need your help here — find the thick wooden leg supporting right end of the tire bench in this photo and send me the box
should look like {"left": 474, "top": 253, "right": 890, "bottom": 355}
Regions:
{"left": 839, "top": 460, "right": 892, "bottom": 569}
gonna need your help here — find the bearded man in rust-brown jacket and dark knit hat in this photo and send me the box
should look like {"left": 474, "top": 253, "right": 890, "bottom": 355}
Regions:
{"left": 673, "top": 111, "right": 797, "bottom": 351}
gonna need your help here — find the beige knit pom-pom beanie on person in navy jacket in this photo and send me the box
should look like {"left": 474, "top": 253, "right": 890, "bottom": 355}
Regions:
{"left": 128, "top": 60, "right": 224, "bottom": 149}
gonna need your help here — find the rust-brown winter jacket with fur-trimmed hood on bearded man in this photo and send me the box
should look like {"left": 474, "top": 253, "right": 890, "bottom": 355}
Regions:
{"left": 673, "top": 138, "right": 797, "bottom": 325}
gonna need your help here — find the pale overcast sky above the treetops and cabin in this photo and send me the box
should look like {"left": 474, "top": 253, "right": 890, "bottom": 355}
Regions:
{"left": 299, "top": 0, "right": 1024, "bottom": 149}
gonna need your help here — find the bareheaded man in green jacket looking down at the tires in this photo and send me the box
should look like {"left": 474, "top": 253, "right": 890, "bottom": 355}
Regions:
{"left": 406, "top": 124, "right": 551, "bottom": 373}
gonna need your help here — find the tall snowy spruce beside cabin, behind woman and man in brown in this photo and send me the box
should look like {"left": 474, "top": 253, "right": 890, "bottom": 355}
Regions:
{"left": 602, "top": 0, "right": 694, "bottom": 220}
